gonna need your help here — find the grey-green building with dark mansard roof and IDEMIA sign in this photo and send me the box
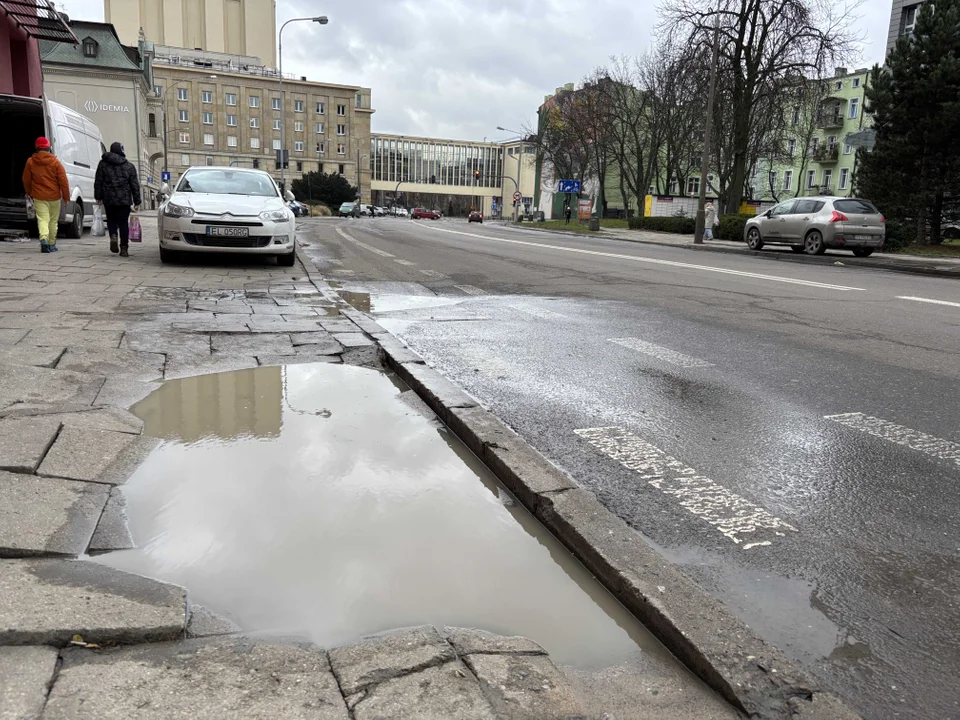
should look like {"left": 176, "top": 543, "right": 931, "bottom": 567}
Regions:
{"left": 40, "top": 20, "right": 163, "bottom": 207}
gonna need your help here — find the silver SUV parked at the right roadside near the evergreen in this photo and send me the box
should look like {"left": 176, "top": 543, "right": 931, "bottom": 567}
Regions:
{"left": 743, "top": 197, "right": 886, "bottom": 257}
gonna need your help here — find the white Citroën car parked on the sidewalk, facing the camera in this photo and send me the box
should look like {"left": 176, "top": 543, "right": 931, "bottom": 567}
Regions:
{"left": 158, "top": 166, "right": 297, "bottom": 267}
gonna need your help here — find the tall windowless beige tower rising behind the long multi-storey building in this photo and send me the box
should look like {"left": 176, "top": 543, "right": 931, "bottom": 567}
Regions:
{"left": 103, "top": 0, "right": 277, "bottom": 67}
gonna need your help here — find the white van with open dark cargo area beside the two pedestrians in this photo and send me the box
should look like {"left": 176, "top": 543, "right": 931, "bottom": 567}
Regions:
{"left": 0, "top": 95, "right": 106, "bottom": 238}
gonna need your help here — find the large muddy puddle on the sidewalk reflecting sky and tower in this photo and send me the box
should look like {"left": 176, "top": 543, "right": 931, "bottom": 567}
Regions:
{"left": 96, "top": 365, "right": 692, "bottom": 680}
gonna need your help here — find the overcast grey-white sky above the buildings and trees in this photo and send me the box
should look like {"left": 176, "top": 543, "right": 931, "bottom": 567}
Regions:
{"left": 57, "top": 0, "right": 890, "bottom": 140}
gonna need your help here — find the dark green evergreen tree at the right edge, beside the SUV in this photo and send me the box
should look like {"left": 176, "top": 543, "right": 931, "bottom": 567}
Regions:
{"left": 857, "top": 0, "right": 960, "bottom": 244}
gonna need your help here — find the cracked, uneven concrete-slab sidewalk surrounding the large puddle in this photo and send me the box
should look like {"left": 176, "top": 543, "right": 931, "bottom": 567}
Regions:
{"left": 0, "top": 222, "right": 580, "bottom": 720}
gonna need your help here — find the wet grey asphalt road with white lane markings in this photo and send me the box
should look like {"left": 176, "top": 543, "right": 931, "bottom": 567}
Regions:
{"left": 301, "top": 218, "right": 960, "bottom": 718}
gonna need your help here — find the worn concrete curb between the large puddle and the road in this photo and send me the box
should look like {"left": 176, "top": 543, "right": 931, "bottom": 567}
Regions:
{"left": 294, "top": 235, "right": 860, "bottom": 720}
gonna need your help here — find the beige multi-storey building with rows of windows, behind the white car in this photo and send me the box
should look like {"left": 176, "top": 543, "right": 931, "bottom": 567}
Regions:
{"left": 150, "top": 45, "right": 374, "bottom": 198}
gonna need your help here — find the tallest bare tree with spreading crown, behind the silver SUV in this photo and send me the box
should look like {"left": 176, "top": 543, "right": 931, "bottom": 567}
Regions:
{"left": 659, "top": 0, "right": 857, "bottom": 212}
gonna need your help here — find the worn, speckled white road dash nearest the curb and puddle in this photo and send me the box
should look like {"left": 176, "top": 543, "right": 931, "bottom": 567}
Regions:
{"left": 574, "top": 427, "right": 797, "bottom": 550}
